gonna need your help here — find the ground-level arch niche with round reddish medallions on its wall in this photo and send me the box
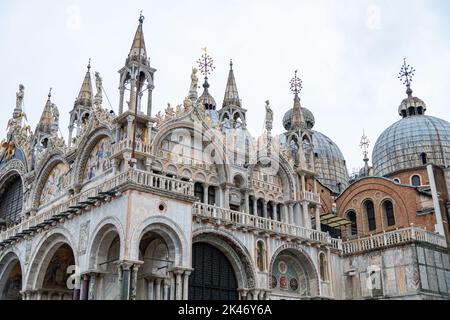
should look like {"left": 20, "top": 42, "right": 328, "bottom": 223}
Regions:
{"left": 269, "top": 248, "right": 319, "bottom": 299}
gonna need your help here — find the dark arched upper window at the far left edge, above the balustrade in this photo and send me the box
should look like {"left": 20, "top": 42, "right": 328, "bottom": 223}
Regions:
{"left": 0, "top": 175, "right": 23, "bottom": 223}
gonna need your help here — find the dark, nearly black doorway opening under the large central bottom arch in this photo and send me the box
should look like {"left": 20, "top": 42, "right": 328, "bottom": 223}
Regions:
{"left": 189, "top": 242, "right": 239, "bottom": 300}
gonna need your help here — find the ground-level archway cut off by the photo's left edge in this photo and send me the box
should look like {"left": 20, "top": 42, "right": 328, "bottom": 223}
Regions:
{"left": 0, "top": 253, "right": 22, "bottom": 300}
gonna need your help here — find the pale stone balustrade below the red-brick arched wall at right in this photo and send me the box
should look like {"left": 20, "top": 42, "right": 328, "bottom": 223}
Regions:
{"left": 342, "top": 227, "right": 447, "bottom": 254}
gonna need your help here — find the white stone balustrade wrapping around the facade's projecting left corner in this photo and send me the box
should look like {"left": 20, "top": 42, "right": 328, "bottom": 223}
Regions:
{"left": 0, "top": 169, "right": 194, "bottom": 242}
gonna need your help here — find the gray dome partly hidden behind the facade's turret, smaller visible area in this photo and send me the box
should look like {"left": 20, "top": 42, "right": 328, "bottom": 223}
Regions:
{"left": 313, "top": 131, "right": 349, "bottom": 193}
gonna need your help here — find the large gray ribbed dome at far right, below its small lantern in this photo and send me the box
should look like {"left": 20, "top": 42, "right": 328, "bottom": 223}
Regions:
{"left": 372, "top": 114, "right": 450, "bottom": 176}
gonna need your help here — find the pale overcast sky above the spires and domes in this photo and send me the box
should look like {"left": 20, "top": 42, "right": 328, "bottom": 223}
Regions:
{"left": 0, "top": 0, "right": 450, "bottom": 172}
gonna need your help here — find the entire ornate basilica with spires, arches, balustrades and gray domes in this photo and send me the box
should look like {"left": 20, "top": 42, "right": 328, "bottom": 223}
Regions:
{"left": 0, "top": 18, "right": 450, "bottom": 300}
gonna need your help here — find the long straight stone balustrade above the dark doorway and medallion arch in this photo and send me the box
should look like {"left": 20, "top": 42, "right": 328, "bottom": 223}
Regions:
{"left": 193, "top": 203, "right": 342, "bottom": 250}
